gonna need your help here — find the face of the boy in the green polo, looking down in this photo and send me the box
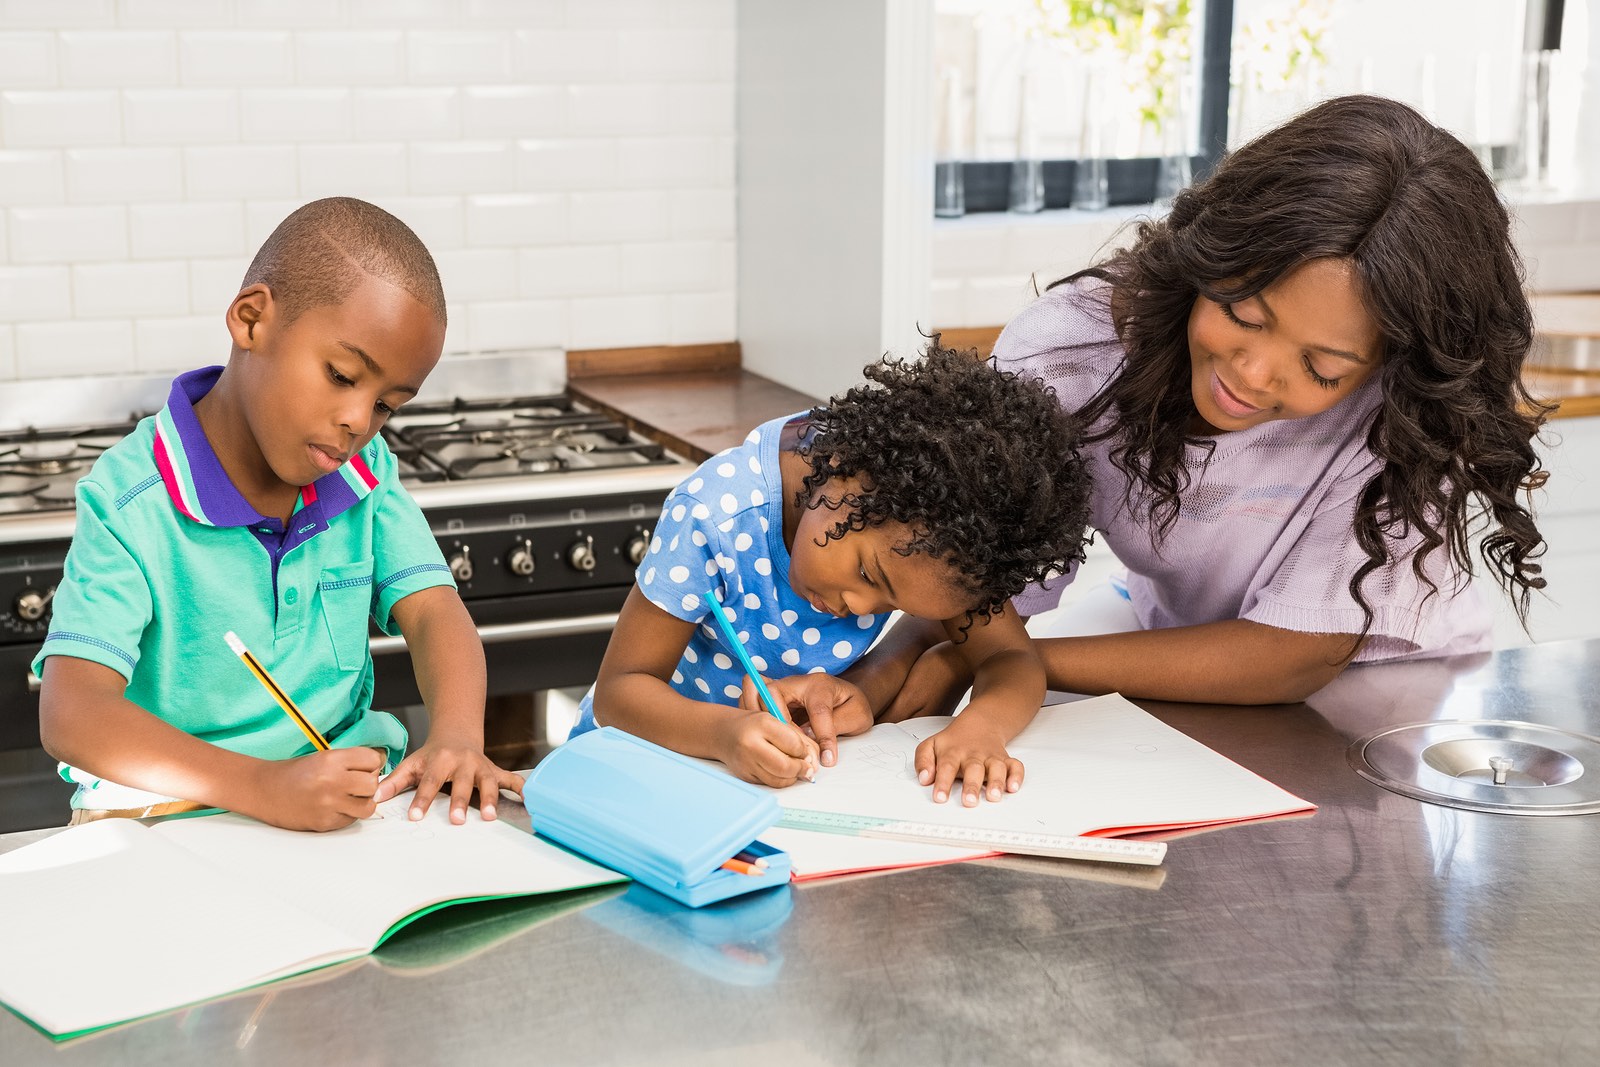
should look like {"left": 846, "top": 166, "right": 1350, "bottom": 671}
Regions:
{"left": 229, "top": 277, "right": 445, "bottom": 486}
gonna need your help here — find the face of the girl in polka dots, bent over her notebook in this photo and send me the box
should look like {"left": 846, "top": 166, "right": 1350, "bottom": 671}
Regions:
{"left": 789, "top": 507, "right": 973, "bottom": 619}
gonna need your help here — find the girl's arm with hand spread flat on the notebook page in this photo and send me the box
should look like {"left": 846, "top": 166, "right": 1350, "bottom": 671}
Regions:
{"left": 915, "top": 605, "right": 1045, "bottom": 808}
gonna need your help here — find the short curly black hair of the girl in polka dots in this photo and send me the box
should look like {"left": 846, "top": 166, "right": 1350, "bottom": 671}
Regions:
{"left": 795, "top": 342, "right": 1090, "bottom": 624}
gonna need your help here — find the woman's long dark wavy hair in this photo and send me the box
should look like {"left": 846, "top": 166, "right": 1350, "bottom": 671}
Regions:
{"left": 1054, "top": 96, "right": 1549, "bottom": 643}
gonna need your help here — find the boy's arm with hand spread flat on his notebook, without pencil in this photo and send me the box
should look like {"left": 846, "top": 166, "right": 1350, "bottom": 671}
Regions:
{"left": 374, "top": 585, "right": 522, "bottom": 824}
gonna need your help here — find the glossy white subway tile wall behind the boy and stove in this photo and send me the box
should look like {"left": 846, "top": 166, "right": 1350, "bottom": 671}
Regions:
{"left": 0, "top": 0, "right": 738, "bottom": 381}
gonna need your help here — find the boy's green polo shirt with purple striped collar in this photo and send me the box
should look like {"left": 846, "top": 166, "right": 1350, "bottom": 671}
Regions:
{"left": 34, "top": 366, "right": 453, "bottom": 808}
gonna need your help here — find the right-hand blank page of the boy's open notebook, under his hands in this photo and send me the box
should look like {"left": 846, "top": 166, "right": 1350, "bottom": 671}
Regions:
{"left": 152, "top": 793, "right": 624, "bottom": 950}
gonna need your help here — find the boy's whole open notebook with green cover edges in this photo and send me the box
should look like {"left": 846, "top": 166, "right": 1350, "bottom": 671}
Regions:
{"left": 0, "top": 793, "right": 626, "bottom": 1038}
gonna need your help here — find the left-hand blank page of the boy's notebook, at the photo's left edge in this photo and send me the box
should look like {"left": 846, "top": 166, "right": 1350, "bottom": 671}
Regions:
{"left": 0, "top": 819, "right": 356, "bottom": 1033}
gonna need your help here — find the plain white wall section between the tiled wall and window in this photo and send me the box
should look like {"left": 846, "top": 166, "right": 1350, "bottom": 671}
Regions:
{"left": 738, "top": 0, "right": 933, "bottom": 397}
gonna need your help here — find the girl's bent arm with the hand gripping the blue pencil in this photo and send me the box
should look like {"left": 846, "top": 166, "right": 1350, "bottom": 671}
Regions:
{"left": 594, "top": 585, "right": 818, "bottom": 785}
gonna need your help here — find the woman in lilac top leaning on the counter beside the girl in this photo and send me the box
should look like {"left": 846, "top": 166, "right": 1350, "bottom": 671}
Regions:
{"left": 864, "top": 96, "right": 1546, "bottom": 718}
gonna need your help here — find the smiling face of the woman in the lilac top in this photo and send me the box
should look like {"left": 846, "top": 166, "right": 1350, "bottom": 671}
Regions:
{"left": 1189, "top": 259, "right": 1382, "bottom": 434}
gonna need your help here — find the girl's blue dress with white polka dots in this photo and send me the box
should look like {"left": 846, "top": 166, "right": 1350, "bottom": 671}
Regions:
{"left": 573, "top": 416, "right": 890, "bottom": 736}
